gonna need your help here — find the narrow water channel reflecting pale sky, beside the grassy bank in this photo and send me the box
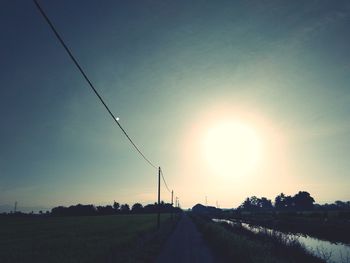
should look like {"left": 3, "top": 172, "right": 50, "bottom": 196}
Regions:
{"left": 213, "top": 218, "right": 350, "bottom": 263}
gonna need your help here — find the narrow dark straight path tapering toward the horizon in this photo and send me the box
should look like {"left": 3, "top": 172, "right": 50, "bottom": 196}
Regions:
{"left": 156, "top": 213, "right": 215, "bottom": 263}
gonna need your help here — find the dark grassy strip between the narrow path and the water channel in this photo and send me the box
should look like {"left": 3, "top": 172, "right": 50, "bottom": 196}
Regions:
{"left": 191, "top": 214, "right": 324, "bottom": 263}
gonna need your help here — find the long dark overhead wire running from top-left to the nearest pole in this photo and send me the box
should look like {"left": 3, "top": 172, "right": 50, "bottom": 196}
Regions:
{"left": 33, "top": 0, "right": 157, "bottom": 169}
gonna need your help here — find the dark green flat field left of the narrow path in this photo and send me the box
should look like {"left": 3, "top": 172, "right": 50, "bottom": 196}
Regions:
{"left": 0, "top": 214, "right": 175, "bottom": 262}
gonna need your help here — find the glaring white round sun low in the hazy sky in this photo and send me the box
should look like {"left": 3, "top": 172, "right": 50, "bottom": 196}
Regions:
{"left": 203, "top": 121, "right": 261, "bottom": 176}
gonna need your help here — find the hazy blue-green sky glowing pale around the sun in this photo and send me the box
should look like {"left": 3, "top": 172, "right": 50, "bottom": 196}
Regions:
{"left": 0, "top": 0, "right": 350, "bottom": 210}
